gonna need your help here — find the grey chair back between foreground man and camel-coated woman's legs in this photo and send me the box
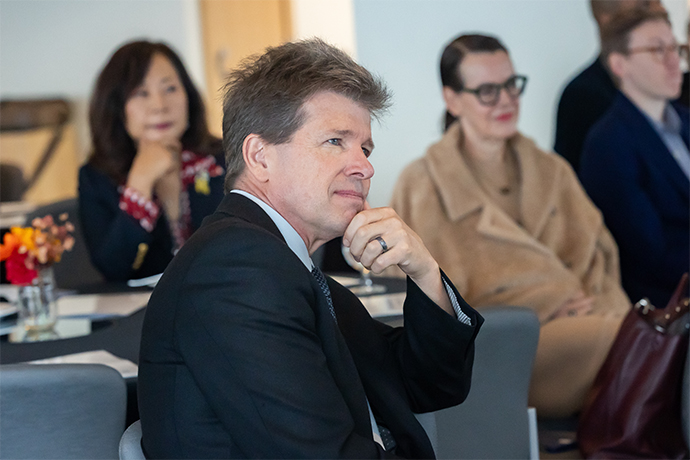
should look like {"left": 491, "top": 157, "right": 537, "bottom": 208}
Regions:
{"left": 435, "top": 307, "right": 539, "bottom": 459}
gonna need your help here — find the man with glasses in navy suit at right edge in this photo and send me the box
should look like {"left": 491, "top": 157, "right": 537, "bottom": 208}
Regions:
{"left": 580, "top": 12, "right": 690, "bottom": 307}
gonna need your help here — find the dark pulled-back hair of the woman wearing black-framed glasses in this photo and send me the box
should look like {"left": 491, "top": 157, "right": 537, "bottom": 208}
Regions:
{"left": 441, "top": 34, "right": 508, "bottom": 131}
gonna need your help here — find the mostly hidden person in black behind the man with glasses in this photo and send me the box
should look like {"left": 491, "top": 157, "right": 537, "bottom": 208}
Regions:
{"left": 554, "top": 0, "right": 664, "bottom": 171}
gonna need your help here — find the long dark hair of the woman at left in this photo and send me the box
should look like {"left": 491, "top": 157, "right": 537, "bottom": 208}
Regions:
{"left": 89, "top": 41, "right": 222, "bottom": 184}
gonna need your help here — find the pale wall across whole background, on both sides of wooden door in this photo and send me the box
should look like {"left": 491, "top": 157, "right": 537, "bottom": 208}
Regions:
{"left": 0, "top": 0, "right": 689, "bottom": 201}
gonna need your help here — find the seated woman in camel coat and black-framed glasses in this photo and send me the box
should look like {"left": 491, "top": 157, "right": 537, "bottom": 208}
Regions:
{"left": 392, "top": 35, "right": 630, "bottom": 416}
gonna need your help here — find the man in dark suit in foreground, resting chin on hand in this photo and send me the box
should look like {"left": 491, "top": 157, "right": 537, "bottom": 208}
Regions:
{"left": 138, "top": 40, "right": 482, "bottom": 458}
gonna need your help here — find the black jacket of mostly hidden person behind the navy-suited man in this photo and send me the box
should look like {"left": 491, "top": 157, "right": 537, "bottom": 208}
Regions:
{"left": 553, "top": 58, "right": 618, "bottom": 171}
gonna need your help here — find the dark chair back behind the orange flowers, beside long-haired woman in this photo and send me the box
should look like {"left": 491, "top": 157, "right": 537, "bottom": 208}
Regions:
{"left": 26, "top": 198, "right": 103, "bottom": 289}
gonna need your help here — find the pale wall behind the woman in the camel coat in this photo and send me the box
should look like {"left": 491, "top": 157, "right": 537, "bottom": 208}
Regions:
{"left": 354, "top": 0, "right": 688, "bottom": 206}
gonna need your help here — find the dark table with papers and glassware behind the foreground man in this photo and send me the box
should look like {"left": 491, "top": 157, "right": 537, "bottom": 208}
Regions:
{"left": 0, "top": 274, "right": 406, "bottom": 424}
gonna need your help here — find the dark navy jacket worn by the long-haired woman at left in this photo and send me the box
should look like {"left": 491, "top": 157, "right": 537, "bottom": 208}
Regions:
{"left": 79, "top": 157, "right": 225, "bottom": 280}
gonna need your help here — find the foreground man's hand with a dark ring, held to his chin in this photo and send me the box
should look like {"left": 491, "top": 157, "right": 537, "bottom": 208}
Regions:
{"left": 343, "top": 203, "right": 455, "bottom": 316}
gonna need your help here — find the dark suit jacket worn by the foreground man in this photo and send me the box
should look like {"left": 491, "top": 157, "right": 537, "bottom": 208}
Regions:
{"left": 138, "top": 193, "right": 483, "bottom": 458}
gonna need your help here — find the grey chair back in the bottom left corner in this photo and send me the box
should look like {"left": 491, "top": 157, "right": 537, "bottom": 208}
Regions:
{"left": 0, "top": 364, "right": 127, "bottom": 459}
